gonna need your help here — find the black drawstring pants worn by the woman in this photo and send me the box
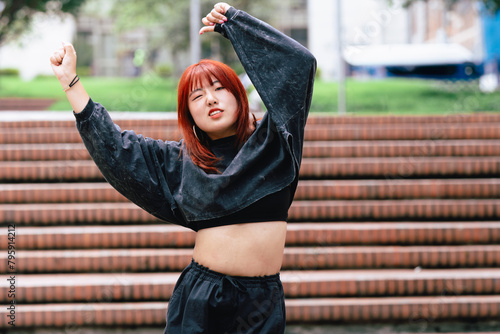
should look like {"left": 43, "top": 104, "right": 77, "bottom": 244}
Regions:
{"left": 164, "top": 261, "right": 285, "bottom": 334}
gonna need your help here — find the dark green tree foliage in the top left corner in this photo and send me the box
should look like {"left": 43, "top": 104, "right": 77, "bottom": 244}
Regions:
{"left": 0, "top": 0, "right": 85, "bottom": 45}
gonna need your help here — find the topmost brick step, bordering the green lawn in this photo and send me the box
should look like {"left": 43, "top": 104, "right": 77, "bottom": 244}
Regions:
{"left": 0, "top": 111, "right": 500, "bottom": 129}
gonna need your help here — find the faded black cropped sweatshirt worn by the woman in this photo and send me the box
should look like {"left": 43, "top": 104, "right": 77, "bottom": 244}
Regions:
{"left": 75, "top": 7, "right": 316, "bottom": 231}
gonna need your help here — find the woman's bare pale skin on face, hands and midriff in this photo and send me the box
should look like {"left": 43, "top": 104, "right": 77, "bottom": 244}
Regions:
{"left": 50, "top": 2, "right": 286, "bottom": 276}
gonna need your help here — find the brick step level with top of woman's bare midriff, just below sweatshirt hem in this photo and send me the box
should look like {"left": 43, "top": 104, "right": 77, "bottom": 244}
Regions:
{"left": 4, "top": 221, "right": 500, "bottom": 250}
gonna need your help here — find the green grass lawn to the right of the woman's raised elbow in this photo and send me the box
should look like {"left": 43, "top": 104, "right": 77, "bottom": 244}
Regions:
{"left": 312, "top": 79, "right": 500, "bottom": 115}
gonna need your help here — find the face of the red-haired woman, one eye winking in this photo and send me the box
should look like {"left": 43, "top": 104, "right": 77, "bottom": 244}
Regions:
{"left": 188, "top": 77, "right": 238, "bottom": 140}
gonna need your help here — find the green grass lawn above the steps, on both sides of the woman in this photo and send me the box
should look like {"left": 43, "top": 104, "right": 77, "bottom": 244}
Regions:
{"left": 0, "top": 76, "right": 500, "bottom": 115}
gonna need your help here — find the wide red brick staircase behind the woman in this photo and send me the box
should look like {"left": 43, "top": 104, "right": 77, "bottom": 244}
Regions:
{"left": 0, "top": 113, "right": 500, "bottom": 333}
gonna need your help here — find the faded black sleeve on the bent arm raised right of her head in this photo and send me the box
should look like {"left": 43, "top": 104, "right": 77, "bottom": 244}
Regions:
{"left": 216, "top": 7, "right": 316, "bottom": 164}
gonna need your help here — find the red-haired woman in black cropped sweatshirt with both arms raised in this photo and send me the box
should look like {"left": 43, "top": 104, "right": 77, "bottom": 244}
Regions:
{"left": 51, "top": 3, "right": 316, "bottom": 334}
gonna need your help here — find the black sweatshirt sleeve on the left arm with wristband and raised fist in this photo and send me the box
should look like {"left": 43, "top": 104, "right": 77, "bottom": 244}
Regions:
{"left": 75, "top": 100, "right": 184, "bottom": 223}
